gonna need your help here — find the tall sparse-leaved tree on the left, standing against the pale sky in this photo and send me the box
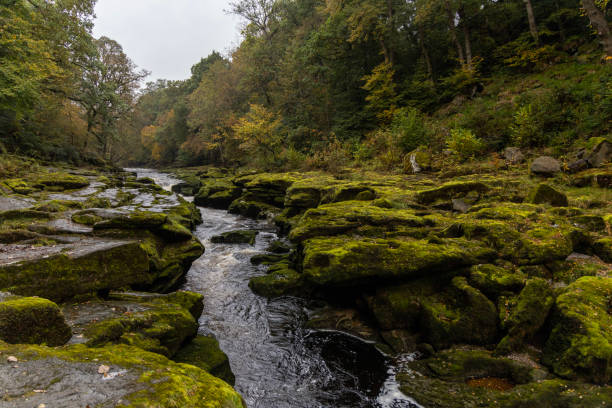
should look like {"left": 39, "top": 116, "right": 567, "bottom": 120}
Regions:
{"left": 78, "top": 37, "right": 148, "bottom": 159}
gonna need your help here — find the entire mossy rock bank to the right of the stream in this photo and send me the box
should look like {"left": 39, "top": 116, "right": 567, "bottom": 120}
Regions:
{"left": 172, "top": 145, "right": 612, "bottom": 408}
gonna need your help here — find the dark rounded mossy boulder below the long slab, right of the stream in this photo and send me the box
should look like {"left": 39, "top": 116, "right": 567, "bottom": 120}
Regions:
{"left": 421, "top": 277, "right": 498, "bottom": 349}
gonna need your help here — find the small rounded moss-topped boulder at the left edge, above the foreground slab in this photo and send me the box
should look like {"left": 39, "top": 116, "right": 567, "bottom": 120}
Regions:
{"left": 0, "top": 297, "right": 72, "bottom": 346}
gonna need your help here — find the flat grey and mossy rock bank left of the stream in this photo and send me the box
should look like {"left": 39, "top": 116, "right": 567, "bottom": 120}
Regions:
{"left": 0, "top": 159, "right": 244, "bottom": 408}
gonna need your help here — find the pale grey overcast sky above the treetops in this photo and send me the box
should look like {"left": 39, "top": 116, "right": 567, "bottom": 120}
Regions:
{"left": 94, "top": 0, "right": 240, "bottom": 81}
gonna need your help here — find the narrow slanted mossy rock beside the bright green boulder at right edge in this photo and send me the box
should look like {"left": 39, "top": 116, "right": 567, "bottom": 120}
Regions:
{"left": 496, "top": 278, "right": 555, "bottom": 353}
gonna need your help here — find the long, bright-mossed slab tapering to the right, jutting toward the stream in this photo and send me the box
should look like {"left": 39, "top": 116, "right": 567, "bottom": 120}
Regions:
{"left": 303, "top": 237, "right": 495, "bottom": 285}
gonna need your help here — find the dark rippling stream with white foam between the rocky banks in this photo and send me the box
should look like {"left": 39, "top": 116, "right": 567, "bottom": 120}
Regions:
{"left": 129, "top": 169, "right": 418, "bottom": 408}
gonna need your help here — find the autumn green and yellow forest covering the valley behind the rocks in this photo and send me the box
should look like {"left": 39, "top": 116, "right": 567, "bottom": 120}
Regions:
{"left": 0, "top": 0, "right": 612, "bottom": 171}
